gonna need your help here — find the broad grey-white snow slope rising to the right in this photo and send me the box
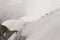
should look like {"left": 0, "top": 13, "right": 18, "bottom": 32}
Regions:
{"left": 22, "top": 8, "right": 60, "bottom": 40}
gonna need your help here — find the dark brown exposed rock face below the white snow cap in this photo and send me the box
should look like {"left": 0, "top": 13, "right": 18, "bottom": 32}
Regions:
{"left": 0, "top": 24, "right": 17, "bottom": 40}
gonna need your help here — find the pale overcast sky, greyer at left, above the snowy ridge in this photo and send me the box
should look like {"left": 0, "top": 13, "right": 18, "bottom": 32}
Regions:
{"left": 0, "top": 0, "right": 60, "bottom": 20}
